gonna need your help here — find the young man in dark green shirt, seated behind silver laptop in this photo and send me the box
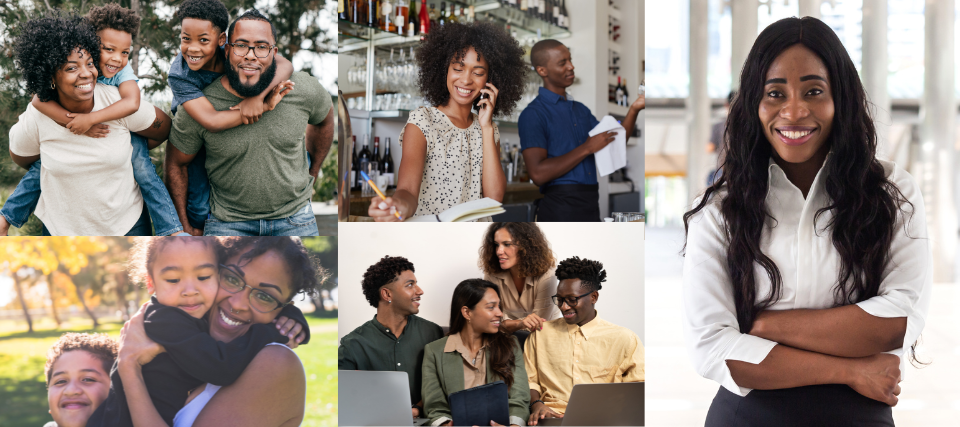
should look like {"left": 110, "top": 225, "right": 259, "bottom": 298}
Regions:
{"left": 337, "top": 256, "right": 443, "bottom": 418}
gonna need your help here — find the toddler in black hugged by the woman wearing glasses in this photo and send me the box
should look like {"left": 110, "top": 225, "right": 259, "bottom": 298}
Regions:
{"left": 87, "top": 237, "right": 309, "bottom": 427}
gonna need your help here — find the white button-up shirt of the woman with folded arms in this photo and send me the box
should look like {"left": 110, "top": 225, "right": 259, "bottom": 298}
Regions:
{"left": 682, "top": 154, "right": 933, "bottom": 396}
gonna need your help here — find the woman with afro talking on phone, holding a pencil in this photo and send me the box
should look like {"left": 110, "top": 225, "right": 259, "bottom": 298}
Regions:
{"left": 368, "top": 22, "right": 525, "bottom": 221}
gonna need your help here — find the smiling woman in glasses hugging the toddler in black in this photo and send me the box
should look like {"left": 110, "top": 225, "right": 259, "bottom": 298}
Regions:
{"left": 118, "top": 237, "right": 323, "bottom": 427}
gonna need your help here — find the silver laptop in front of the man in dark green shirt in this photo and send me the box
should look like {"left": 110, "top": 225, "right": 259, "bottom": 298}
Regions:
{"left": 337, "top": 371, "right": 428, "bottom": 426}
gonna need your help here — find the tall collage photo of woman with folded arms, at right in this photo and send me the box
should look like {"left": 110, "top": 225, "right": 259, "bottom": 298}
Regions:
{"left": 645, "top": 0, "right": 960, "bottom": 427}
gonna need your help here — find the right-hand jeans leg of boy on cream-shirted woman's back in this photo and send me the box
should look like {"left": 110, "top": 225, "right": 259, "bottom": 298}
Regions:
{"left": 130, "top": 133, "right": 183, "bottom": 236}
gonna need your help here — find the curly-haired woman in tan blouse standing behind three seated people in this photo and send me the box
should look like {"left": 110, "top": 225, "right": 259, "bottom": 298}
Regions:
{"left": 478, "top": 222, "right": 560, "bottom": 333}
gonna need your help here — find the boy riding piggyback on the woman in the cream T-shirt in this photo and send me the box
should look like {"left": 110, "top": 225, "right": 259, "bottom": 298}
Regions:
{"left": 0, "top": 3, "right": 183, "bottom": 236}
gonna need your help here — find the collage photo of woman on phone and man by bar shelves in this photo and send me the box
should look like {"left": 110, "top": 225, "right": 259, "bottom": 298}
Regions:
{"left": 337, "top": 0, "right": 645, "bottom": 222}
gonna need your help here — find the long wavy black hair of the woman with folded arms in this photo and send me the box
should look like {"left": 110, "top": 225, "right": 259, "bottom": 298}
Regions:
{"left": 683, "top": 17, "right": 913, "bottom": 333}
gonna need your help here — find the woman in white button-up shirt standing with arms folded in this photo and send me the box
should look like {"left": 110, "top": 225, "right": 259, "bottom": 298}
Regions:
{"left": 683, "top": 18, "right": 931, "bottom": 426}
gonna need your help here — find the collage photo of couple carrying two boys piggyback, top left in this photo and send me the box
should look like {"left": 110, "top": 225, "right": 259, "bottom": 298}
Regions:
{"left": 0, "top": 0, "right": 337, "bottom": 236}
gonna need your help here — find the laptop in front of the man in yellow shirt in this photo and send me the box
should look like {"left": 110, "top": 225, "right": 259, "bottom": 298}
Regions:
{"left": 537, "top": 383, "right": 645, "bottom": 426}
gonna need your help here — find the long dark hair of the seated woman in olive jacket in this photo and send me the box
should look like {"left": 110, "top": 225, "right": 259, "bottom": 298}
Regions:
{"left": 449, "top": 279, "right": 516, "bottom": 388}
